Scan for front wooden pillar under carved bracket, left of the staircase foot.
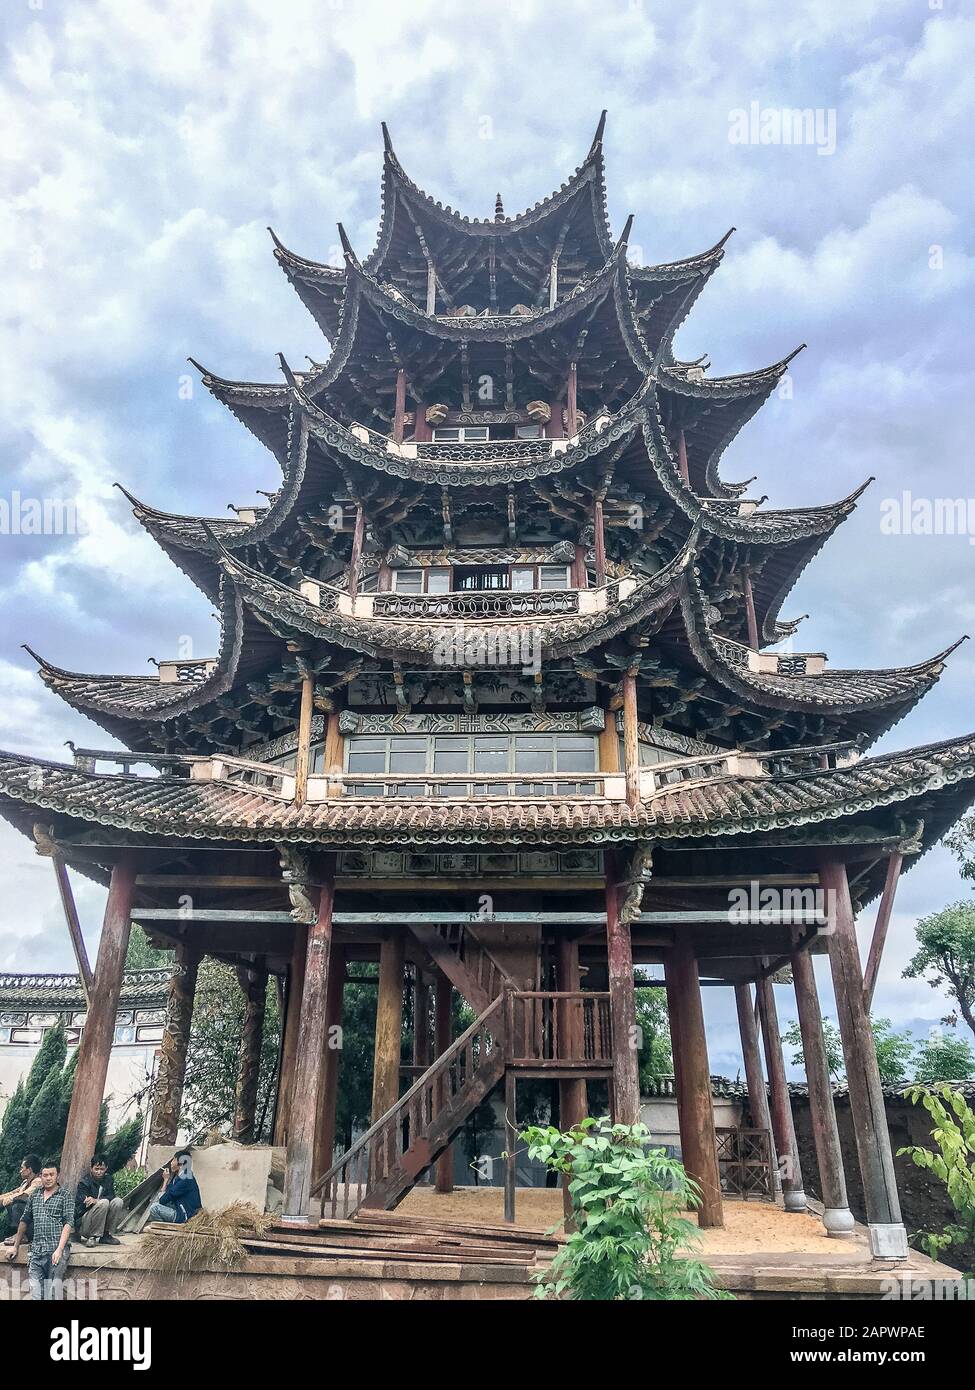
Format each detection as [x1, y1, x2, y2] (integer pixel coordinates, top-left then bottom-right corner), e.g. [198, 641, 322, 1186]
[281, 865, 335, 1226]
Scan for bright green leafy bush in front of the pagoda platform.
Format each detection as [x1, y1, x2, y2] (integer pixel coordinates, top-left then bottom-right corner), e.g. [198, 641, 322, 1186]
[520, 1116, 730, 1301]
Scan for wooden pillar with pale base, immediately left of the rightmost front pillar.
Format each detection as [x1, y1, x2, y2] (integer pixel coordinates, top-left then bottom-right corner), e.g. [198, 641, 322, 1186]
[791, 951, 854, 1237]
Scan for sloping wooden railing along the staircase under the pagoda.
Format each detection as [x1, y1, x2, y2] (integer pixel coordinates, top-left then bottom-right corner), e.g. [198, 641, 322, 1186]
[312, 997, 505, 1218]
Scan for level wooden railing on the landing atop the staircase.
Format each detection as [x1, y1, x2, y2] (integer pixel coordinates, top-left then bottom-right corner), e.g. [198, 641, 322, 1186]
[505, 990, 612, 1070]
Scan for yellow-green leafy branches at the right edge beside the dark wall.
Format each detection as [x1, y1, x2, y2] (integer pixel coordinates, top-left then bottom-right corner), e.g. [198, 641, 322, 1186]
[897, 1081, 975, 1259]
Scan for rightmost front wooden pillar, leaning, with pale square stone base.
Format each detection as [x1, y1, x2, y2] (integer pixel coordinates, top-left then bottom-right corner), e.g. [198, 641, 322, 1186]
[819, 855, 907, 1259]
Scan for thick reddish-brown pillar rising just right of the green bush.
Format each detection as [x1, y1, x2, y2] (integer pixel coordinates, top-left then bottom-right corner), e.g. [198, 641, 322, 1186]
[666, 933, 725, 1230]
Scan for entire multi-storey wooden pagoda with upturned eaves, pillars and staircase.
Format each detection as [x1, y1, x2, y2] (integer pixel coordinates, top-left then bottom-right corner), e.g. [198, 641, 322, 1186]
[0, 114, 975, 1258]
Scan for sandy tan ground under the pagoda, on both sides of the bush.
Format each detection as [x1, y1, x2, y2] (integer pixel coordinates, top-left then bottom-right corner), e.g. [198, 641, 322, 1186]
[398, 1187, 865, 1255]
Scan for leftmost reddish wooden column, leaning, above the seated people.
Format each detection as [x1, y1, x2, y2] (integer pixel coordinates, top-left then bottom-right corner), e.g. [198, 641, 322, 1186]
[61, 853, 136, 1190]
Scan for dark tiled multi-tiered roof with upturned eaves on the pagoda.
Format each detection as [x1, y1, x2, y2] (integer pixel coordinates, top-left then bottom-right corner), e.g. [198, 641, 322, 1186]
[0, 113, 975, 906]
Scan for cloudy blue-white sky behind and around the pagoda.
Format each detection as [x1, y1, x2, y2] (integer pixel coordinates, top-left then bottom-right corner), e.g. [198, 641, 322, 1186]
[0, 0, 975, 1074]
